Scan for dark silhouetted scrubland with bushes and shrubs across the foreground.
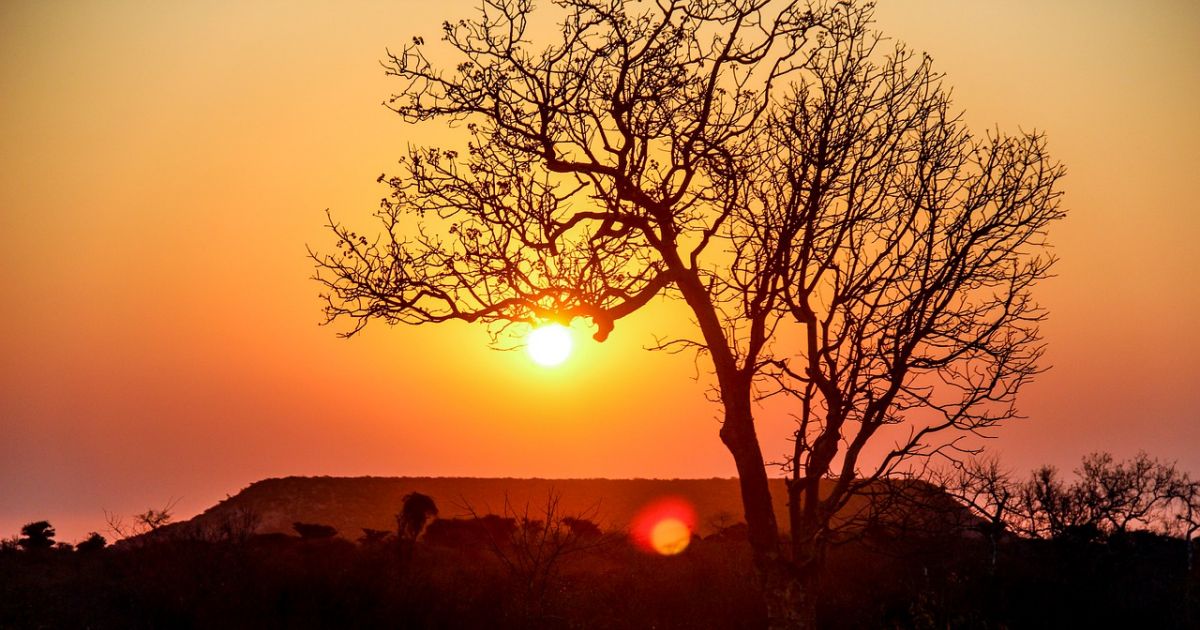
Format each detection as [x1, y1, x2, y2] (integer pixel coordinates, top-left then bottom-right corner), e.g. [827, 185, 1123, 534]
[0, 454, 1200, 629]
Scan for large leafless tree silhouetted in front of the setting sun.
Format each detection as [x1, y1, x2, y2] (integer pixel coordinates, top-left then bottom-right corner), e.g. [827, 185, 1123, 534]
[312, 0, 1063, 626]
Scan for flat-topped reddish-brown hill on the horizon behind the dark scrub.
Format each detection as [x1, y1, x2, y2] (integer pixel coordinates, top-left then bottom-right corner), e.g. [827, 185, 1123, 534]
[154, 476, 965, 540]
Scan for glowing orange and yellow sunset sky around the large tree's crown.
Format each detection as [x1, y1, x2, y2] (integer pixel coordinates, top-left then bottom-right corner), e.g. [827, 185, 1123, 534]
[0, 0, 1200, 541]
